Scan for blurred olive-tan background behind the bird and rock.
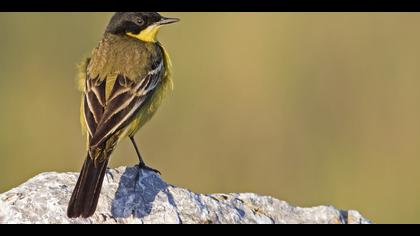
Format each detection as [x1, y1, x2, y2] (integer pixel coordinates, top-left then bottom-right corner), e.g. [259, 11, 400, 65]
[0, 13, 420, 223]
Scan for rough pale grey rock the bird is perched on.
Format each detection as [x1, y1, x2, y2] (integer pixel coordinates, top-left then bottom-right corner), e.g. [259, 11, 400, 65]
[0, 167, 370, 224]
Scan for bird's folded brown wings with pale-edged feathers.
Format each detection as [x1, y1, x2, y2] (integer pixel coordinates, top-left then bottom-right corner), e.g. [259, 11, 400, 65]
[84, 63, 163, 148]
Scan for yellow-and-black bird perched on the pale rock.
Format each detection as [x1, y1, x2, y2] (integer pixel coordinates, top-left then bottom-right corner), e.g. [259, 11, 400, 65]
[67, 12, 179, 218]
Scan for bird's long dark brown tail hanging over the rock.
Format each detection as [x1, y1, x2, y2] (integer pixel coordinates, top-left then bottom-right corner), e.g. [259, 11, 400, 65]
[67, 152, 108, 218]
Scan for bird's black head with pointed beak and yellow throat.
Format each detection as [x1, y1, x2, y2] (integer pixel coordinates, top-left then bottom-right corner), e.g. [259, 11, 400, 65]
[106, 12, 179, 39]
